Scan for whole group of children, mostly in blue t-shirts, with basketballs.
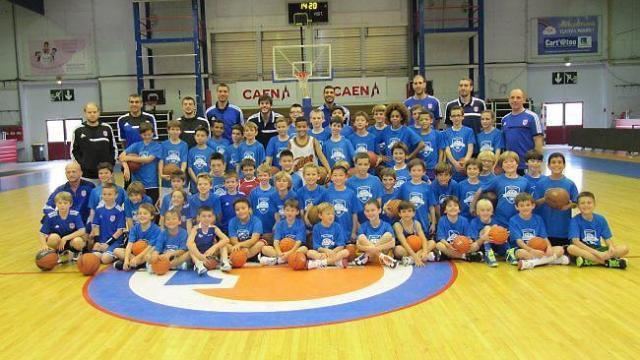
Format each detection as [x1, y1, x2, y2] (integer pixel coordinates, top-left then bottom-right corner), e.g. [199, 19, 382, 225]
[41, 100, 628, 275]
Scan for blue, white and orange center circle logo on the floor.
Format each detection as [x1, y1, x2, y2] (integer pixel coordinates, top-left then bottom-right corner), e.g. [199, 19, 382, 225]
[84, 262, 457, 330]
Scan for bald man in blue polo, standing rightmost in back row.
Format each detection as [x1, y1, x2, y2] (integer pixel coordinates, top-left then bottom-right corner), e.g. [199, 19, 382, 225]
[502, 89, 544, 175]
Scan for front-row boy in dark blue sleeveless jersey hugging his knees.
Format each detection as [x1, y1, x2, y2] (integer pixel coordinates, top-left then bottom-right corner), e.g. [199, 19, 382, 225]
[187, 206, 231, 276]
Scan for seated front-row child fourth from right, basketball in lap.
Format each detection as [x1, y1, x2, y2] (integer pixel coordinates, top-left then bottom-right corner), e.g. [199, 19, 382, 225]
[436, 196, 483, 262]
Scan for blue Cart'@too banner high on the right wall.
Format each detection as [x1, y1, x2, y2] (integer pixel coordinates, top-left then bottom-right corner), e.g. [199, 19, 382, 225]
[538, 16, 599, 55]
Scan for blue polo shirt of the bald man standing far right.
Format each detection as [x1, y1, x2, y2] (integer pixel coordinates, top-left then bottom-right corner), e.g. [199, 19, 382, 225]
[502, 110, 543, 169]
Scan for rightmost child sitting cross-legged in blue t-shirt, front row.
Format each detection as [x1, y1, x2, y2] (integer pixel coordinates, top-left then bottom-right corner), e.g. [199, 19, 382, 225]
[567, 191, 629, 269]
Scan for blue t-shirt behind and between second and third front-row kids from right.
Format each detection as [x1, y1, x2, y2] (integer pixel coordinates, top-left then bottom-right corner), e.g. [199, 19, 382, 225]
[482, 174, 529, 227]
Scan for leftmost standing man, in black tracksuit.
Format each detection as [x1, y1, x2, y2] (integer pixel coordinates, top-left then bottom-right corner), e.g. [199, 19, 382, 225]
[71, 102, 118, 184]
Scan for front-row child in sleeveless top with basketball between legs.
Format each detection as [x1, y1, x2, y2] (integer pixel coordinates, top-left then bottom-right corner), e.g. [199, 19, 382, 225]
[393, 201, 439, 267]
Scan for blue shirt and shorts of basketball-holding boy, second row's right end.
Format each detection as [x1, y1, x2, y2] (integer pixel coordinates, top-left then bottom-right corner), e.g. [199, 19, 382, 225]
[533, 176, 578, 238]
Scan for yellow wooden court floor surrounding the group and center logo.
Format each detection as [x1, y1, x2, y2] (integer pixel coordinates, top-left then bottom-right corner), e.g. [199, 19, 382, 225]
[0, 151, 640, 359]
